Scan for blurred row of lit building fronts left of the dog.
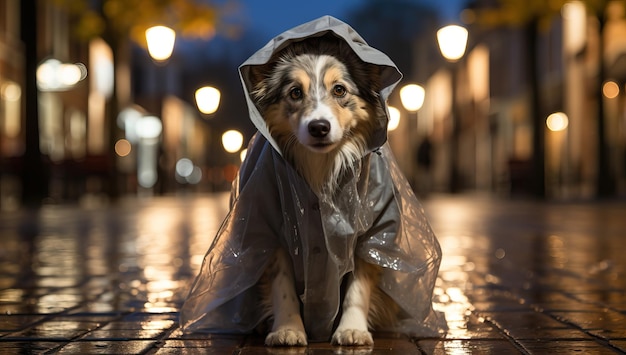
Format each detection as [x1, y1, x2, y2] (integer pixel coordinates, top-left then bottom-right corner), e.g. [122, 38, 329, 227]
[0, 0, 239, 209]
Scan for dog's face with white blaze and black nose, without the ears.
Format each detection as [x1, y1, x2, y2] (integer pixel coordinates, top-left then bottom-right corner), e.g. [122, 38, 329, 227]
[265, 54, 369, 153]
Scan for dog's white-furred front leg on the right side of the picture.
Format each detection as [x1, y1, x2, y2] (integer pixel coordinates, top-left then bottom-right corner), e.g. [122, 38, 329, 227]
[332, 259, 377, 345]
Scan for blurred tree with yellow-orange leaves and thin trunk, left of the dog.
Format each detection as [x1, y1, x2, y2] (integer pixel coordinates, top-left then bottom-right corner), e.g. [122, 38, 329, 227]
[45, 0, 240, 198]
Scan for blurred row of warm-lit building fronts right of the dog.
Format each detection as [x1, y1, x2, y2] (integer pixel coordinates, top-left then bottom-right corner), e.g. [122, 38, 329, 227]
[404, 0, 626, 198]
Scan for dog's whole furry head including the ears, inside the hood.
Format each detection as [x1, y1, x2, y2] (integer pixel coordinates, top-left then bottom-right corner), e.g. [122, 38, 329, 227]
[252, 39, 382, 155]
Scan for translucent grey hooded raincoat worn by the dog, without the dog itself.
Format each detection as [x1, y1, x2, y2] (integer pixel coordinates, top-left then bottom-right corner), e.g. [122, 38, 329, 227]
[180, 16, 446, 341]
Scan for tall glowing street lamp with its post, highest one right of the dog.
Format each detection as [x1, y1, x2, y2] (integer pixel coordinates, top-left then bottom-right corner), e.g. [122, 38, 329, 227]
[437, 25, 468, 193]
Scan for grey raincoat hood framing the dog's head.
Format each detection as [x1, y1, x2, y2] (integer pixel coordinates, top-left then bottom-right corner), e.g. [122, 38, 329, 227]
[239, 16, 402, 156]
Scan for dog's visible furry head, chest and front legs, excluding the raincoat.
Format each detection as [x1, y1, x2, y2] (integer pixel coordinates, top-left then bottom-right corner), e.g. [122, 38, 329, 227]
[251, 35, 398, 346]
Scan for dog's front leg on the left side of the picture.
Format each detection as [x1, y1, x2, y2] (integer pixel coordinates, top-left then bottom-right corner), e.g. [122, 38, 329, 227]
[265, 249, 307, 346]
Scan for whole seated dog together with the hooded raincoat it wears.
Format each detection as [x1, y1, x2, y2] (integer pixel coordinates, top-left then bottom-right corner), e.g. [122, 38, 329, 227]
[180, 16, 447, 346]
